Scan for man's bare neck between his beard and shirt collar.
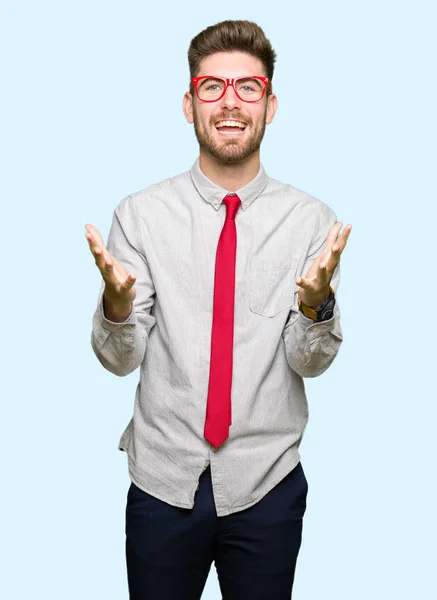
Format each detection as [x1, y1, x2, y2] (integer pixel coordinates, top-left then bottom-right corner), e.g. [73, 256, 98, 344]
[199, 148, 260, 192]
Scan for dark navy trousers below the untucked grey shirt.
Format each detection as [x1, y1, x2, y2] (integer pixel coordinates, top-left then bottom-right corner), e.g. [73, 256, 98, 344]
[126, 463, 308, 600]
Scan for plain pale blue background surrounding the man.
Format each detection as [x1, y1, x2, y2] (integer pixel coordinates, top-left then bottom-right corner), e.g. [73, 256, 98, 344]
[0, 0, 437, 600]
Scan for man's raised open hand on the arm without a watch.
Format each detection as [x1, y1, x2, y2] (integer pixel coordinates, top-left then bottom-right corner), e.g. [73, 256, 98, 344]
[85, 224, 136, 322]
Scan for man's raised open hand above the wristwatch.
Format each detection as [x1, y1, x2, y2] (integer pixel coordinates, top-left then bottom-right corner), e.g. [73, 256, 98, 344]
[296, 222, 352, 308]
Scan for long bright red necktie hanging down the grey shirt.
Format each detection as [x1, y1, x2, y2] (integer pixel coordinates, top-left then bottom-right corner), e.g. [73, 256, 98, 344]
[204, 195, 241, 448]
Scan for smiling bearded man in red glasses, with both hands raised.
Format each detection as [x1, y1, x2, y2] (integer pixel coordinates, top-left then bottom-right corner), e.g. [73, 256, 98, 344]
[86, 21, 351, 600]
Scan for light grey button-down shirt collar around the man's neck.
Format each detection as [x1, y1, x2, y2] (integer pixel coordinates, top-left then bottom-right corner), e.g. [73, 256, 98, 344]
[190, 158, 268, 210]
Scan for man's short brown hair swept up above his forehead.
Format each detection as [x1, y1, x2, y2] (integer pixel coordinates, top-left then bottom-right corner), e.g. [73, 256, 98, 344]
[188, 20, 276, 93]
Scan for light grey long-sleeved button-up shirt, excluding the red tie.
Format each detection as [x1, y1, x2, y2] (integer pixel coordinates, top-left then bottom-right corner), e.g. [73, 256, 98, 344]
[91, 159, 342, 516]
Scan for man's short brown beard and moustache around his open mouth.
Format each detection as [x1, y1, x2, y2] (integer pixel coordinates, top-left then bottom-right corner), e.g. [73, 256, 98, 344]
[193, 105, 267, 165]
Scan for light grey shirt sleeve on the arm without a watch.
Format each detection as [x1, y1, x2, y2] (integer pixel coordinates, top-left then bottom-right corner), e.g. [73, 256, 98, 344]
[91, 197, 156, 377]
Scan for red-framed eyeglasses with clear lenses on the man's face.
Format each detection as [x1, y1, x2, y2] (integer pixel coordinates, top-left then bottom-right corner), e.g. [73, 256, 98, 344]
[191, 75, 269, 102]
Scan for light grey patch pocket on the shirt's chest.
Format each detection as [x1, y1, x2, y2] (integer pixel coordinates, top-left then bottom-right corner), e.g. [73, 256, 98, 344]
[249, 258, 297, 317]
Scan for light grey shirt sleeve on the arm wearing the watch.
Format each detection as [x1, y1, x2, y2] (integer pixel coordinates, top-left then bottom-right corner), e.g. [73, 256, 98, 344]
[282, 203, 343, 377]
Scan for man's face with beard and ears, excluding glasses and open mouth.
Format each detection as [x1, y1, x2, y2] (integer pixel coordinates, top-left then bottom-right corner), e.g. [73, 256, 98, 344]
[183, 52, 277, 164]
